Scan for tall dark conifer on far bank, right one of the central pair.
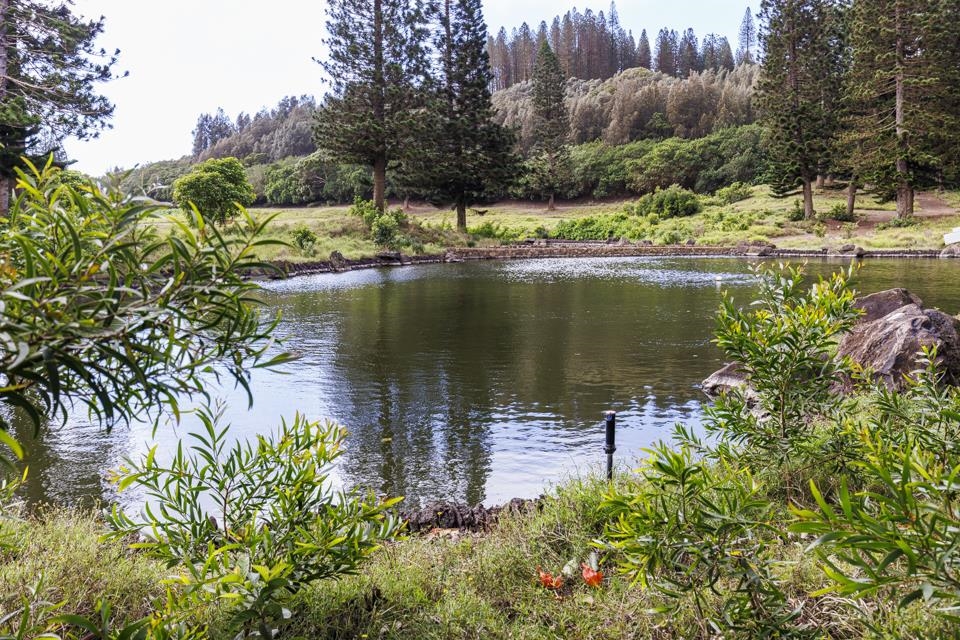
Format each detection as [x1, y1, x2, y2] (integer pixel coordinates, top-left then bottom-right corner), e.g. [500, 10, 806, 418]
[404, 0, 516, 231]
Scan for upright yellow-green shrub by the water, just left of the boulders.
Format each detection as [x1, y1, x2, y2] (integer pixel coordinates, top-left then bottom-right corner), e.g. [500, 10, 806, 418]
[707, 268, 857, 480]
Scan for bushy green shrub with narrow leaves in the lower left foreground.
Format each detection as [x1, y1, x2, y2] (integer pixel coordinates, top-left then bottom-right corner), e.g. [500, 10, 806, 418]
[107, 411, 398, 638]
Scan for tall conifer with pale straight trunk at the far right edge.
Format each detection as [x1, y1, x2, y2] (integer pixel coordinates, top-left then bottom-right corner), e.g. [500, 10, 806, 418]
[845, 0, 960, 218]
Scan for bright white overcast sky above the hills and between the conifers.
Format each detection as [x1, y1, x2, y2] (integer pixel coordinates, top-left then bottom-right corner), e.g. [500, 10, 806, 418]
[67, 0, 759, 175]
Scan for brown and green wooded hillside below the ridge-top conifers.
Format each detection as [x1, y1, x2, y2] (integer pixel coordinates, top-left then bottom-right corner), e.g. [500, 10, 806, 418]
[123, 65, 763, 205]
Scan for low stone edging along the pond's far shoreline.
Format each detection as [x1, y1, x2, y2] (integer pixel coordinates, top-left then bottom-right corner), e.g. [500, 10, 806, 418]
[253, 240, 956, 278]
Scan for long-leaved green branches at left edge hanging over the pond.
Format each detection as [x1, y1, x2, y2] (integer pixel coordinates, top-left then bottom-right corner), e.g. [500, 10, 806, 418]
[0, 160, 286, 470]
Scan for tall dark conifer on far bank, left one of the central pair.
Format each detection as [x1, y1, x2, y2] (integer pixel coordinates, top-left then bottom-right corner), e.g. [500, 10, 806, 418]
[314, 0, 428, 210]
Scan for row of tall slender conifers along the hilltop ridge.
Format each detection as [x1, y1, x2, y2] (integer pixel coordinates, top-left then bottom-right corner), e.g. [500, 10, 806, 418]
[487, 3, 757, 91]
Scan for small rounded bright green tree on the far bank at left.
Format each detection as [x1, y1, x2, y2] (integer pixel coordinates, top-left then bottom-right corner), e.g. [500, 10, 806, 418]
[173, 158, 257, 224]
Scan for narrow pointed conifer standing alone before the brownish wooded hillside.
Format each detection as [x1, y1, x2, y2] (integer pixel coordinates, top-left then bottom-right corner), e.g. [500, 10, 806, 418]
[532, 42, 569, 210]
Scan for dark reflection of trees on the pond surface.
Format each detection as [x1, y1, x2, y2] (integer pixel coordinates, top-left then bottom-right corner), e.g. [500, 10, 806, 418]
[314, 264, 728, 502]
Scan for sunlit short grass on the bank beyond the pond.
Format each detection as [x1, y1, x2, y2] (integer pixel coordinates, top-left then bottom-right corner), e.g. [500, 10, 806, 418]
[150, 186, 960, 262]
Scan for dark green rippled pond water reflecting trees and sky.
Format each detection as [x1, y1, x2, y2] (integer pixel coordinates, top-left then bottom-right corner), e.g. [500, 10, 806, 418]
[16, 258, 960, 504]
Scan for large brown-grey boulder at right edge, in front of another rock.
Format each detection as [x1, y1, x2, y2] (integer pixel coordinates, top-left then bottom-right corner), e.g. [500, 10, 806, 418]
[837, 303, 960, 389]
